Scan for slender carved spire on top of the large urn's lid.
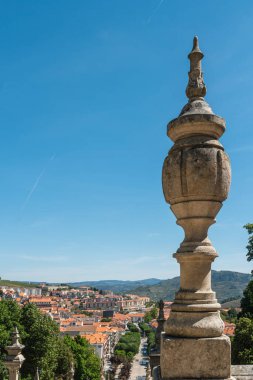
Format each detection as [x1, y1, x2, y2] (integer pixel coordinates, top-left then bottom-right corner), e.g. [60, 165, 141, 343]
[186, 36, 206, 101]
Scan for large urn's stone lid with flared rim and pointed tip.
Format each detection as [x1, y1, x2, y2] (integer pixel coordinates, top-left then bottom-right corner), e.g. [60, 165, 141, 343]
[167, 36, 225, 141]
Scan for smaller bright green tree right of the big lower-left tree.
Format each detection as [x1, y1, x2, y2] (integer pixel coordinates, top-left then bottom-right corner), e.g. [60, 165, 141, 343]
[64, 336, 101, 380]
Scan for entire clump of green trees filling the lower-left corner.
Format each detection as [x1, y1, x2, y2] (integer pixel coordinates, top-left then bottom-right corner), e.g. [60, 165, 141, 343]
[0, 300, 100, 380]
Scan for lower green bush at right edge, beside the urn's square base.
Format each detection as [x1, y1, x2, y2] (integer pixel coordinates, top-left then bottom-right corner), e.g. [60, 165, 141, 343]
[232, 318, 253, 364]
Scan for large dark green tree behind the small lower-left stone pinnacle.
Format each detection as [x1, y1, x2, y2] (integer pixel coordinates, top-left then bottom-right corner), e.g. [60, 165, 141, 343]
[0, 300, 73, 380]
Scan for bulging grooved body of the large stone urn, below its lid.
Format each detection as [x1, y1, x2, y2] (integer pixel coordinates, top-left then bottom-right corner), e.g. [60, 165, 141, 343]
[163, 139, 230, 205]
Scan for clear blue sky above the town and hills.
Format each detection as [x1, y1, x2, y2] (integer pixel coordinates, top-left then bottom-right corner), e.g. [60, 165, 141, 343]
[0, 0, 253, 281]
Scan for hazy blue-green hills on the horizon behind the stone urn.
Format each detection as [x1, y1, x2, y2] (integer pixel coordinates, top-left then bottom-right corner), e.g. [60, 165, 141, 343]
[69, 271, 251, 302]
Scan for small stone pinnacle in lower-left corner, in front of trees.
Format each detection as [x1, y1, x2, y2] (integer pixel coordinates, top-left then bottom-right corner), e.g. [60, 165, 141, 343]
[4, 328, 25, 380]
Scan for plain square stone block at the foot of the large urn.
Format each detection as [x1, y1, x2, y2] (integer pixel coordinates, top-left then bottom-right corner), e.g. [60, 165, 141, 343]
[160, 335, 231, 380]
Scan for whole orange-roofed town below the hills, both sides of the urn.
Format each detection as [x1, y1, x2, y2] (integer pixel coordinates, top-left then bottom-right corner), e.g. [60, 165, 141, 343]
[0, 281, 239, 373]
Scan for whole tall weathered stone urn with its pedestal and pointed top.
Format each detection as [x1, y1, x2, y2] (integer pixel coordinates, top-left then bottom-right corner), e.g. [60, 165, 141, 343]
[161, 37, 231, 379]
